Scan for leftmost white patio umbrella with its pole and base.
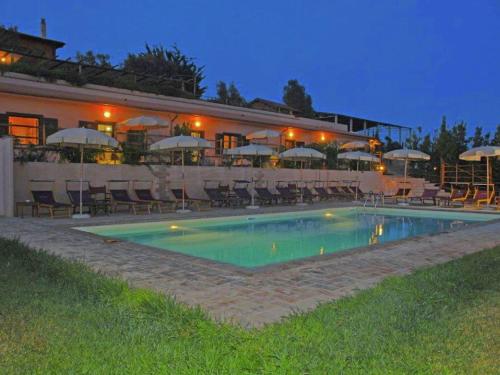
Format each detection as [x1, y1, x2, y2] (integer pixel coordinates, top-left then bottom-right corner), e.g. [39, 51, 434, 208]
[46, 128, 119, 219]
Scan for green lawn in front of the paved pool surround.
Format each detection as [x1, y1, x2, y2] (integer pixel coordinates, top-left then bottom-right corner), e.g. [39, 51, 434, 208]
[0, 239, 500, 374]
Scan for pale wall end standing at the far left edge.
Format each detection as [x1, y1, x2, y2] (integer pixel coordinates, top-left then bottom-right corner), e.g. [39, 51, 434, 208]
[0, 137, 14, 216]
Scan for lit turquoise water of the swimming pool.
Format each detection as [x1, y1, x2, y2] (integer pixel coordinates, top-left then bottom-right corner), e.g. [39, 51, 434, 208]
[76, 208, 495, 268]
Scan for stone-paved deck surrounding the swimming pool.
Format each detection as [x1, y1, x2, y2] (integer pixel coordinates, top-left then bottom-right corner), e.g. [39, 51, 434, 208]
[0, 203, 500, 327]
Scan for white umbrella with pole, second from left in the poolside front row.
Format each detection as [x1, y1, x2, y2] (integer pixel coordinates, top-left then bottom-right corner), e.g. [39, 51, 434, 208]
[149, 135, 212, 213]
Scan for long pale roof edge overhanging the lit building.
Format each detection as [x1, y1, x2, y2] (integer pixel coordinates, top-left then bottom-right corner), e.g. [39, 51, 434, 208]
[0, 72, 370, 139]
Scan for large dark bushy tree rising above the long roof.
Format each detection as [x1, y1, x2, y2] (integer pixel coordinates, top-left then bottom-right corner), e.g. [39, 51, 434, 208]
[123, 44, 206, 97]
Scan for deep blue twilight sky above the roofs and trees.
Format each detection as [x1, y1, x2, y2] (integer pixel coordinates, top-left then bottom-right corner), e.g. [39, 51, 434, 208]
[0, 0, 500, 135]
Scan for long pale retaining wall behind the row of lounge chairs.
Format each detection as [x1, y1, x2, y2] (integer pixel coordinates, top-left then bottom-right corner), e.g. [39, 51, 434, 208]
[14, 162, 424, 201]
